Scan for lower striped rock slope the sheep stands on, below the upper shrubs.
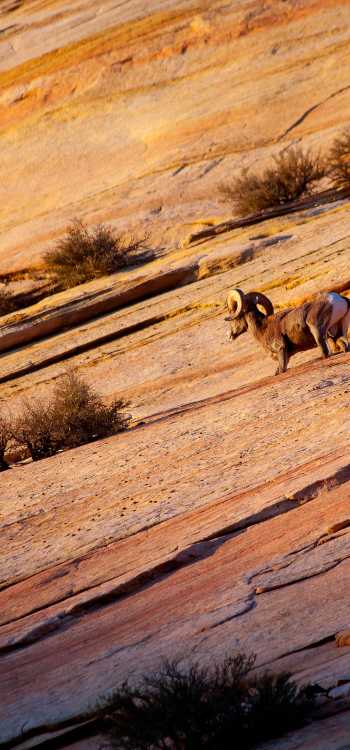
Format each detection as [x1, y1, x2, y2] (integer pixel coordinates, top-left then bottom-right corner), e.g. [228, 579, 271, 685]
[0, 201, 350, 747]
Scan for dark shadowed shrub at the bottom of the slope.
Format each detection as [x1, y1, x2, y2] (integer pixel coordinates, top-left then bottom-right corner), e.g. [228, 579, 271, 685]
[100, 654, 310, 750]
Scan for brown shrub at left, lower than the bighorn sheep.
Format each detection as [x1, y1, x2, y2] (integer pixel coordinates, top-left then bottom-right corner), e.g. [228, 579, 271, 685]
[12, 370, 130, 461]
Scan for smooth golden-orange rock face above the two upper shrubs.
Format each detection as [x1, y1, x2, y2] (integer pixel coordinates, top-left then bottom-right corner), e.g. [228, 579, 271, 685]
[0, 0, 350, 274]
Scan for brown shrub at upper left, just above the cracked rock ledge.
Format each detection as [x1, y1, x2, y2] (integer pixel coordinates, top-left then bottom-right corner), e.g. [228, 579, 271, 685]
[44, 220, 147, 289]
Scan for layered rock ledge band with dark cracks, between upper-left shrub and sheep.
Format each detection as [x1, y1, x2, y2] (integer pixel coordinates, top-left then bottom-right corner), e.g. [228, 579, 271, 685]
[0, 197, 350, 362]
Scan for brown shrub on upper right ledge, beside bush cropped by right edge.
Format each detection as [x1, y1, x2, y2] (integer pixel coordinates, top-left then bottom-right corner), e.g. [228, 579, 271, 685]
[220, 146, 326, 215]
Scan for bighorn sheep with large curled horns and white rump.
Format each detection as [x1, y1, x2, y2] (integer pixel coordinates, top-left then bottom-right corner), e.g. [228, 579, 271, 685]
[225, 289, 350, 375]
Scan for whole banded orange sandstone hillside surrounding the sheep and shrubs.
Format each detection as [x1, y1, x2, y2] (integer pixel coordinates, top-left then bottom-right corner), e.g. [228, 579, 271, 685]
[0, 0, 350, 750]
